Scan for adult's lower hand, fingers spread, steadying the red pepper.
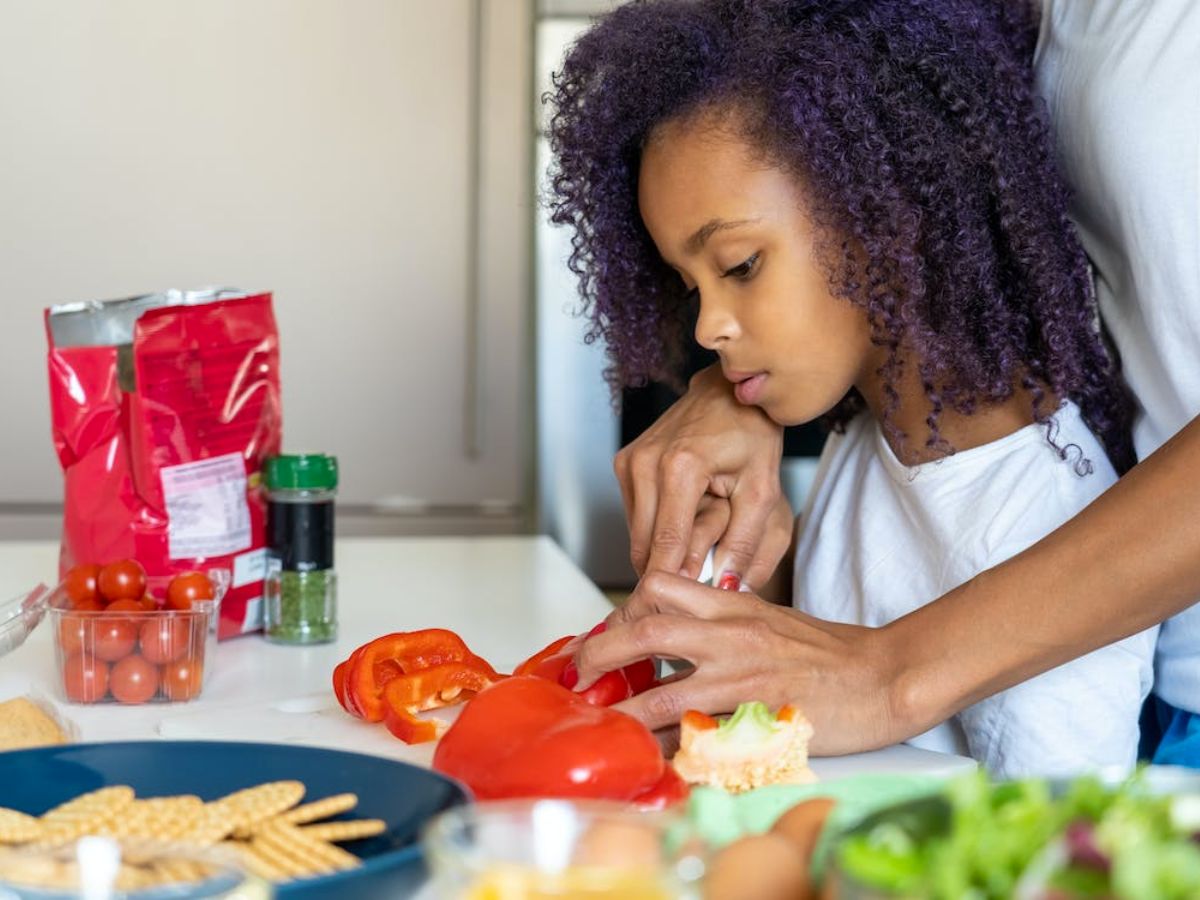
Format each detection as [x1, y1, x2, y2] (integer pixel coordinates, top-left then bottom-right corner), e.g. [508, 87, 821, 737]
[575, 572, 907, 755]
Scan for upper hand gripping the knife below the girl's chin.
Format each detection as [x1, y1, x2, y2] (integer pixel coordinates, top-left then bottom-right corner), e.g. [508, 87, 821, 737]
[613, 365, 792, 587]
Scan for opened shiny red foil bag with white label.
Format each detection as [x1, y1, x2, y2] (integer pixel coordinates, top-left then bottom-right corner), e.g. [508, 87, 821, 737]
[46, 290, 282, 637]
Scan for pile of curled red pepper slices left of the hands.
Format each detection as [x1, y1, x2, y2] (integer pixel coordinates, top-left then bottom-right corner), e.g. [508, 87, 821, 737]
[334, 628, 504, 744]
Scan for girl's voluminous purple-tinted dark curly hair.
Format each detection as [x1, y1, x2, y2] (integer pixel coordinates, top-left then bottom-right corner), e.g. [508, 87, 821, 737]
[548, 0, 1133, 469]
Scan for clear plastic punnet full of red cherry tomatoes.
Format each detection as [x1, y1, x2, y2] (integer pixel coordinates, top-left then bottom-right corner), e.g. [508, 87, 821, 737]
[32, 559, 229, 704]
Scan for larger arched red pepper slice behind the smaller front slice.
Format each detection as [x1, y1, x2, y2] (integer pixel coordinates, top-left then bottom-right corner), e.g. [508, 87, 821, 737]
[345, 628, 499, 722]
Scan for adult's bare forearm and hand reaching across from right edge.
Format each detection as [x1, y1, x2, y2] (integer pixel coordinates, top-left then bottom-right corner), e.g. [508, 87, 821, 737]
[576, 419, 1200, 754]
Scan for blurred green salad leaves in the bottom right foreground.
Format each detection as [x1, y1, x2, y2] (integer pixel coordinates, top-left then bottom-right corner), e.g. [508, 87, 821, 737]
[828, 767, 1200, 900]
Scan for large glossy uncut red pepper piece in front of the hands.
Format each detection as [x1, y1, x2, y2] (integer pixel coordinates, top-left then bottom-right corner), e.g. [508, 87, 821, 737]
[433, 676, 666, 800]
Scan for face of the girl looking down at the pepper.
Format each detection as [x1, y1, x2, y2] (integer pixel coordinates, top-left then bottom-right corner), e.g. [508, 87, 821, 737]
[638, 115, 882, 425]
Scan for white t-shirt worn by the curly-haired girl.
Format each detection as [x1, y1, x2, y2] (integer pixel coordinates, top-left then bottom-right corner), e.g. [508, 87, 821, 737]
[793, 403, 1157, 776]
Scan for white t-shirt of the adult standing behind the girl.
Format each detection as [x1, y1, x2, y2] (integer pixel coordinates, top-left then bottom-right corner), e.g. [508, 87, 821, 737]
[1037, 0, 1200, 713]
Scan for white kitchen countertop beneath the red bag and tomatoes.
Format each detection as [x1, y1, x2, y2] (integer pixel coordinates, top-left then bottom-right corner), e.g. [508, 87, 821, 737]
[0, 536, 973, 778]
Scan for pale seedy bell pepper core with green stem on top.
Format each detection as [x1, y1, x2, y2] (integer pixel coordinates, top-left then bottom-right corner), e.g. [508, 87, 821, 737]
[674, 702, 816, 793]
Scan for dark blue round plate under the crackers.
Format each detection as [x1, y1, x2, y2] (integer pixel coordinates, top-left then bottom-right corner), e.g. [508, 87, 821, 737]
[0, 740, 467, 900]
